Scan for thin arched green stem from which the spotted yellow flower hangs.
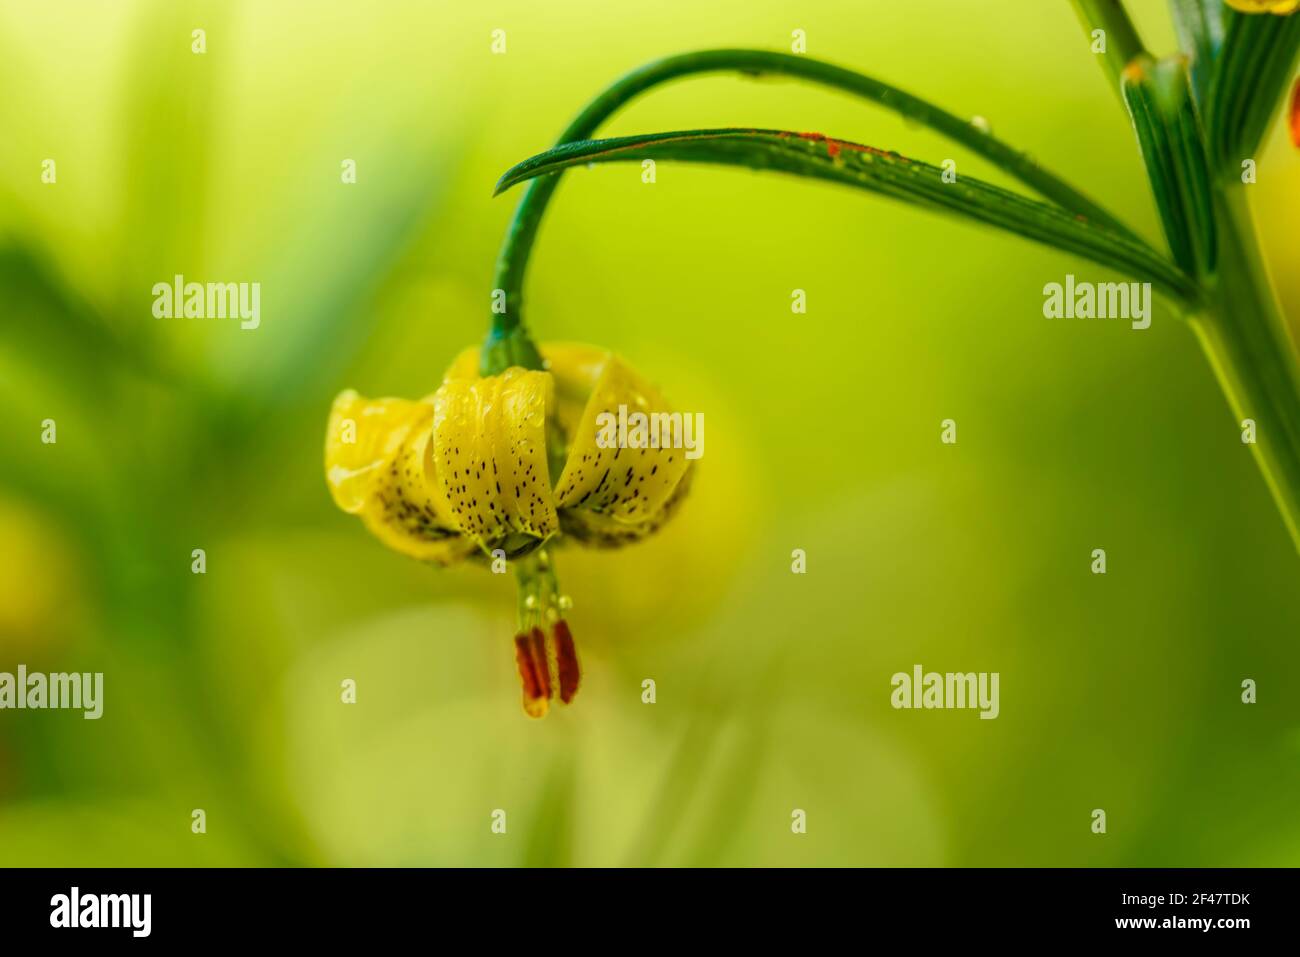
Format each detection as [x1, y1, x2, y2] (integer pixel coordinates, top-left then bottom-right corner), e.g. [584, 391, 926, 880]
[481, 49, 1136, 374]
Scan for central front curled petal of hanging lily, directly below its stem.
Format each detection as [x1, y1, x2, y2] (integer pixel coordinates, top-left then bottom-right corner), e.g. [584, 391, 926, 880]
[433, 368, 559, 554]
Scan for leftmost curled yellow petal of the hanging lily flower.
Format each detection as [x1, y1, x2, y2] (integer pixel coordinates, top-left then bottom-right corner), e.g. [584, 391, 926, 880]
[325, 390, 473, 564]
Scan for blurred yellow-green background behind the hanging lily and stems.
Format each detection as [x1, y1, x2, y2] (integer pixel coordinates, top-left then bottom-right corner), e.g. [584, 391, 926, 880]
[0, 0, 1300, 866]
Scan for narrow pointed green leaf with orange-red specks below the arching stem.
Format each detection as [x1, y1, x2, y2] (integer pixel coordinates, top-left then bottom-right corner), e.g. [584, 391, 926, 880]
[497, 129, 1197, 300]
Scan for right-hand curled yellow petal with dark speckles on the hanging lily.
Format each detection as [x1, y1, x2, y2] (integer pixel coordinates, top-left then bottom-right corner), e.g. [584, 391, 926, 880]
[555, 355, 690, 530]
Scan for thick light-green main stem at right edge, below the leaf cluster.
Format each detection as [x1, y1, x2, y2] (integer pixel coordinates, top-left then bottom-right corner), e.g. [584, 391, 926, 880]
[1192, 185, 1300, 551]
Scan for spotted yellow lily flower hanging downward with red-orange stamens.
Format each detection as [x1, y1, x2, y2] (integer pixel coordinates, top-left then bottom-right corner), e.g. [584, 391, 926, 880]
[325, 345, 692, 718]
